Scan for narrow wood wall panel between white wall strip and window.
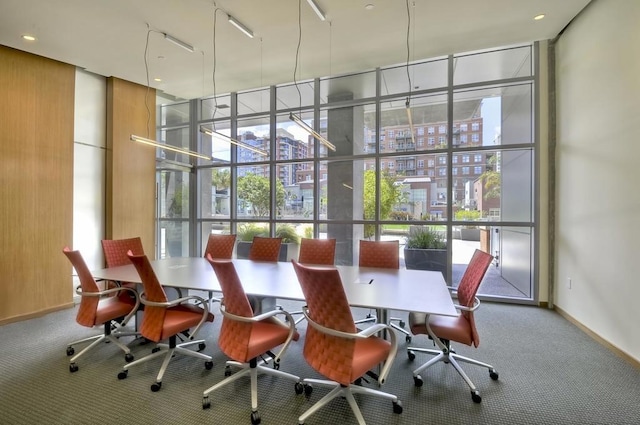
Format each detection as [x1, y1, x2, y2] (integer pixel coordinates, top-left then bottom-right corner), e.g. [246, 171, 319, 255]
[105, 77, 156, 258]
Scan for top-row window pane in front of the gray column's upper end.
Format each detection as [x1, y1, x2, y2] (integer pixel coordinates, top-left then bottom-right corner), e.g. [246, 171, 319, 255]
[320, 71, 376, 105]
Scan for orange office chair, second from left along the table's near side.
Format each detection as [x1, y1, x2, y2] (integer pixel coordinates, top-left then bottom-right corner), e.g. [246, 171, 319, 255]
[118, 252, 213, 392]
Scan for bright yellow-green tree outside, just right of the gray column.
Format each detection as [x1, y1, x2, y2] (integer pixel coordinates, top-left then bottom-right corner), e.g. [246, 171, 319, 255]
[363, 170, 402, 238]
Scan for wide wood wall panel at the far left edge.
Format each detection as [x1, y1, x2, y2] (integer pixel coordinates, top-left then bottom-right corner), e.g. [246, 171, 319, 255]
[0, 46, 75, 324]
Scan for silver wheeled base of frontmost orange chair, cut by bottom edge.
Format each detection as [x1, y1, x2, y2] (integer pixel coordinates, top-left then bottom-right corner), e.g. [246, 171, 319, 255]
[298, 378, 402, 425]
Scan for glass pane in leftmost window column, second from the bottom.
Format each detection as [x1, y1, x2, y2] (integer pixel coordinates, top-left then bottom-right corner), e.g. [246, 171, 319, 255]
[159, 170, 189, 218]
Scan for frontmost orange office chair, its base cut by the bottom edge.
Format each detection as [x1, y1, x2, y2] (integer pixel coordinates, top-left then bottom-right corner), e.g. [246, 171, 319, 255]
[293, 261, 402, 425]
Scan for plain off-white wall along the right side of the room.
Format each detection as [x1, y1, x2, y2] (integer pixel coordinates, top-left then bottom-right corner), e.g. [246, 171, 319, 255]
[555, 0, 640, 361]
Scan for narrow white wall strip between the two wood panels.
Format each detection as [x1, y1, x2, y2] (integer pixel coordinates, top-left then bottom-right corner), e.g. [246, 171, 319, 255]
[73, 69, 107, 288]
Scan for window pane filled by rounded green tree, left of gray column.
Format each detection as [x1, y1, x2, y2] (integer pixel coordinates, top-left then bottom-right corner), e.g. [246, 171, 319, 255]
[237, 165, 272, 218]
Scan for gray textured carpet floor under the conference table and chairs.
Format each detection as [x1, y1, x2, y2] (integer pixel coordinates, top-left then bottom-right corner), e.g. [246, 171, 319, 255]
[0, 303, 640, 425]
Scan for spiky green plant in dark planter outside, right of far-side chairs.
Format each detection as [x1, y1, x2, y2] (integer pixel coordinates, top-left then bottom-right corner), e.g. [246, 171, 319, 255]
[404, 226, 448, 280]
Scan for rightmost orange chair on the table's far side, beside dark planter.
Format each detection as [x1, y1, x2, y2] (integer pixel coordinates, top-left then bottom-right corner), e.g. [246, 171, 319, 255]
[356, 240, 411, 342]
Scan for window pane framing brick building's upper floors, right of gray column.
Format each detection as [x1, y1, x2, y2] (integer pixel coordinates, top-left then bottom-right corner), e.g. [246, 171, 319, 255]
[378, 94, 448, 153]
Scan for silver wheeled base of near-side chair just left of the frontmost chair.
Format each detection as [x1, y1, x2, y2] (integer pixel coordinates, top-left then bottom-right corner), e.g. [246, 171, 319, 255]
[202, 359, 304, 424]
